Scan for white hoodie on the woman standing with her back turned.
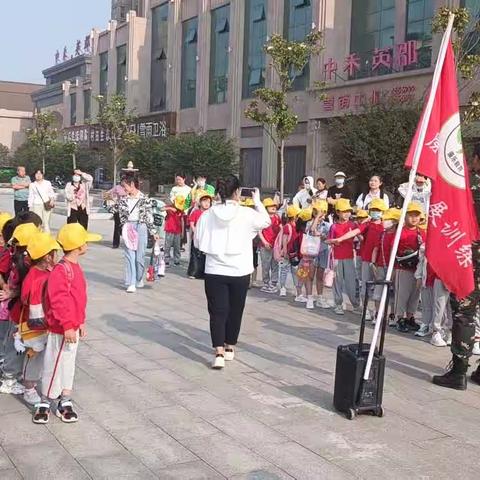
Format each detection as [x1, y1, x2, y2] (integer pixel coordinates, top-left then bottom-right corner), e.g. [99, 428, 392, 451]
[195, 201, 271, 277]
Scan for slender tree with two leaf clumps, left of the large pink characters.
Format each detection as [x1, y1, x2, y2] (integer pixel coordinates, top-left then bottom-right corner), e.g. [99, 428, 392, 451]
[245, 32, 323, 199]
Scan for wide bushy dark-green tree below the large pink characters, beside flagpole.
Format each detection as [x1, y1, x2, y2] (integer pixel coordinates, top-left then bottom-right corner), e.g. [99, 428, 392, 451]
[327, 101, 420, 189]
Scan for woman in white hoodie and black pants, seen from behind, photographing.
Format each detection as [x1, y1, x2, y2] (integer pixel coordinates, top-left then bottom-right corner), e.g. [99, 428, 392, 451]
[195, 175, 270, 369]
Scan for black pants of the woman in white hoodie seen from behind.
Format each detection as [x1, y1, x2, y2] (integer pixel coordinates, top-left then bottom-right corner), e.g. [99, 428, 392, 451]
[205, 274, 250, 348]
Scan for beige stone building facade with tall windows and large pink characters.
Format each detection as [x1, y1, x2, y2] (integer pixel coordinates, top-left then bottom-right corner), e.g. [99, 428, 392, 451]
[43, 0, 480, 192]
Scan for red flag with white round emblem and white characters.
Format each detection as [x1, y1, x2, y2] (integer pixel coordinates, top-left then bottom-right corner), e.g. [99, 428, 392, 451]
[406, 41, 478, 298]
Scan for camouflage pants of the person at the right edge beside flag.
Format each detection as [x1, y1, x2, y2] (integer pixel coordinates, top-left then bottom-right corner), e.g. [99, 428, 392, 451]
[451, 242, 480, 372]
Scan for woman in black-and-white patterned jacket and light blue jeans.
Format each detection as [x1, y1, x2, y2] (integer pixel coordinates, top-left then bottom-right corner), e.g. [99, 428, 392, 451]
[109, 173, 158, 293]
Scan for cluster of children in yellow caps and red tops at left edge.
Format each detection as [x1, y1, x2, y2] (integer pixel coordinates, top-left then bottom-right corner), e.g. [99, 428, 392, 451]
[0, 212, 101, 424]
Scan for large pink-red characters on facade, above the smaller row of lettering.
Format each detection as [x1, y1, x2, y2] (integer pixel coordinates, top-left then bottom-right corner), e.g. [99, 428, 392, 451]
[323, 40, 419, 81]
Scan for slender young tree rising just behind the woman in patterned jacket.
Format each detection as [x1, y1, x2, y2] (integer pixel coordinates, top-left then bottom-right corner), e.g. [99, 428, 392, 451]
[95, 95, 140, 182]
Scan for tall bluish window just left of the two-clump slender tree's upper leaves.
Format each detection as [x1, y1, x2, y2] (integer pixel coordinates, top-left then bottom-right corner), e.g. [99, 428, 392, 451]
[243, 0, 267, 98]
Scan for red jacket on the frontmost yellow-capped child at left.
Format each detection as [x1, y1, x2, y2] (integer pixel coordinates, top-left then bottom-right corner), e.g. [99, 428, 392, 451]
[45, 259, 87, 335]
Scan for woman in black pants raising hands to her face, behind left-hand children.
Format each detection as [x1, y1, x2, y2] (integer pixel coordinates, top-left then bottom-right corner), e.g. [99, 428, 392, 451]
[65, 169, 93, 230]
